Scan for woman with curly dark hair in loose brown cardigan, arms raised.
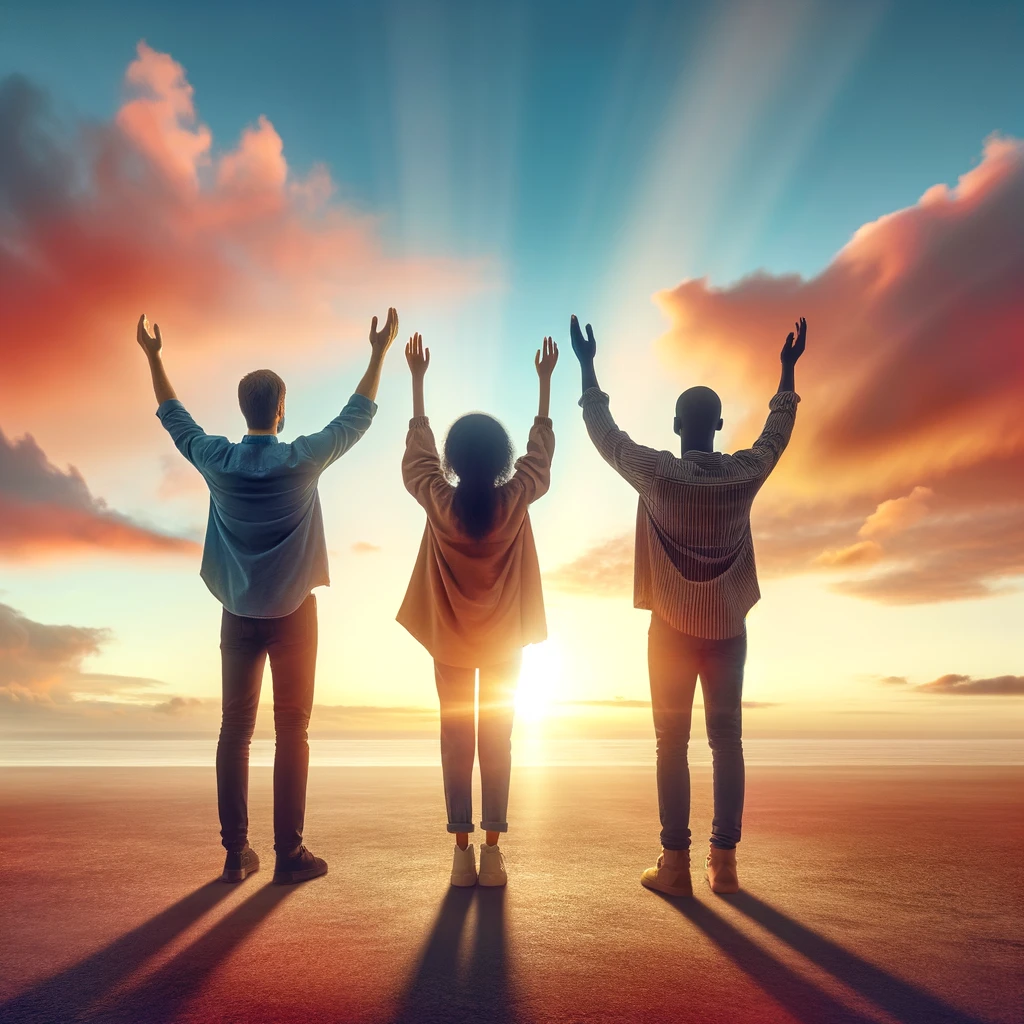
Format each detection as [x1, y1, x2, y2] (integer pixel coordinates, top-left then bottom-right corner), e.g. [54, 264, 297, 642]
[398, 334, 558, 886]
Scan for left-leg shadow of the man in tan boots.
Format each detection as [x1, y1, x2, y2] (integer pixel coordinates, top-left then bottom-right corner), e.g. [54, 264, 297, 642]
[656, 893, 873, 1024]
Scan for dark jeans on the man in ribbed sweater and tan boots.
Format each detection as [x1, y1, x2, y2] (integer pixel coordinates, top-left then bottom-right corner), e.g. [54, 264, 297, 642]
[647, 615, 746, 850]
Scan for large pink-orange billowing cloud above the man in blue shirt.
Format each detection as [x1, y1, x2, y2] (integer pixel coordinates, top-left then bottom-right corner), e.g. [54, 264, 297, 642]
[0, 43, 490, 444]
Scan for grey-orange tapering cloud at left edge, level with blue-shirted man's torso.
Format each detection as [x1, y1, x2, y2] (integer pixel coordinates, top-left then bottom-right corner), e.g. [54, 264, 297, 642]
[0, 430, 199, 559]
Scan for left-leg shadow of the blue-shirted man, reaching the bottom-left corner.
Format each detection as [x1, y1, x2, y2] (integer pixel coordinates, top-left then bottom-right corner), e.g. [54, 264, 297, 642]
[0, 880, 231, 1024]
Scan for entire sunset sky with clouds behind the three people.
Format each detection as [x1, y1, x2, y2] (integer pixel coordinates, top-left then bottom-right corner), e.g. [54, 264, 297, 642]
[0, 0, 1024, 736]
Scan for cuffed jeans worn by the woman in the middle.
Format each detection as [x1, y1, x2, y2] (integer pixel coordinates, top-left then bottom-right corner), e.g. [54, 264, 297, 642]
[434, 652, 522, 833]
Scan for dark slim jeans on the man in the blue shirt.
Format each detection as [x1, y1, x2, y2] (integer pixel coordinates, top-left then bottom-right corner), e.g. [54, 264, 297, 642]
[217, 594, 316, 857]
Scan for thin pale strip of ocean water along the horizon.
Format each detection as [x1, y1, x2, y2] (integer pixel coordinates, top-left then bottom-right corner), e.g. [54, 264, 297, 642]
[0, 736, 1024, 768]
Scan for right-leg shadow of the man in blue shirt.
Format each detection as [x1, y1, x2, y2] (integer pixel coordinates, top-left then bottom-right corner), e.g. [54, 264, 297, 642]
[83, 884, 295, 1024]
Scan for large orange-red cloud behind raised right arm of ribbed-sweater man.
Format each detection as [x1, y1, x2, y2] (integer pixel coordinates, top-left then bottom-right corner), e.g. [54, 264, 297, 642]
[657, 137, 1024, 603]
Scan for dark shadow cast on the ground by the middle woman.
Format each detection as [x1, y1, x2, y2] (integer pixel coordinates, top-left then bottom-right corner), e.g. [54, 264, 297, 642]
[392, 888, 522, 1024]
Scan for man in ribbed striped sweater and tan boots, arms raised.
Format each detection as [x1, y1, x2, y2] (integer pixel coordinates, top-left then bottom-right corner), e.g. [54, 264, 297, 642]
[569, 316, 807, 896]
